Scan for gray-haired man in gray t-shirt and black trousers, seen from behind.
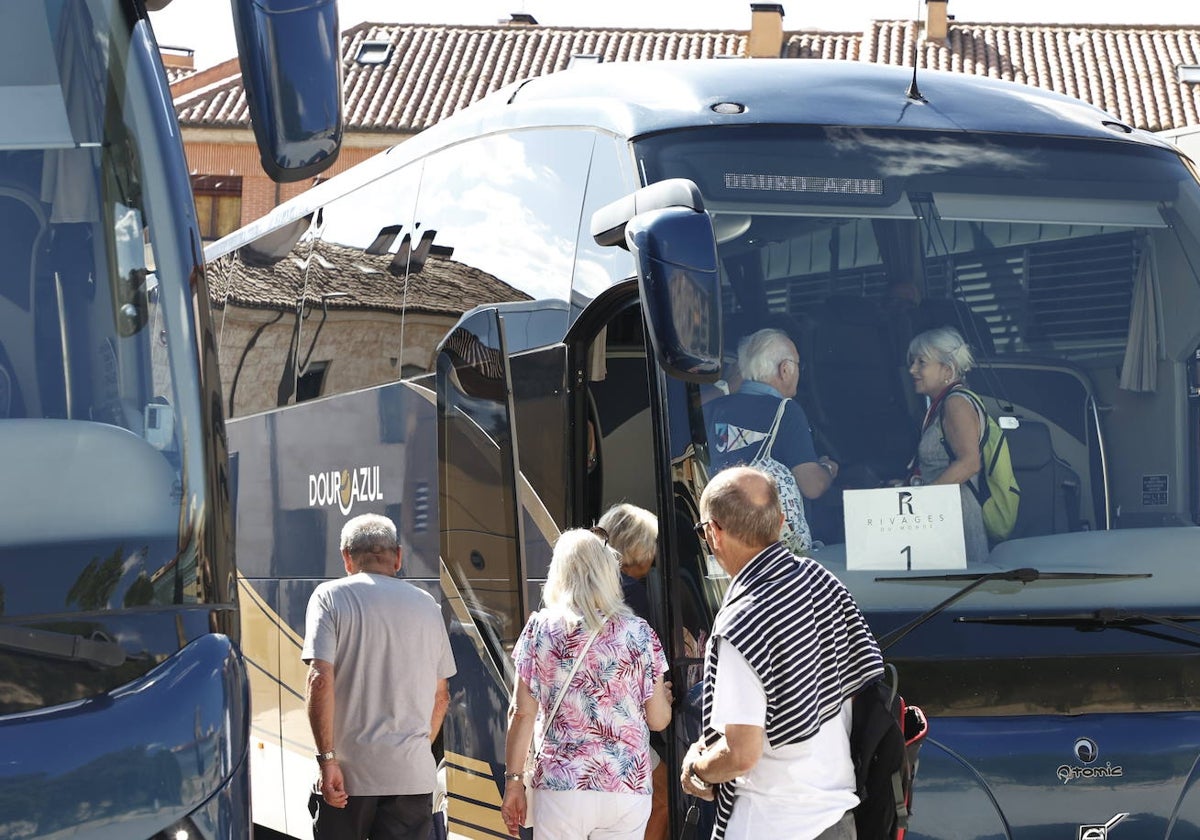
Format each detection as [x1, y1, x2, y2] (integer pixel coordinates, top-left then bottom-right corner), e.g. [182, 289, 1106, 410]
[300, 514, 455, 840]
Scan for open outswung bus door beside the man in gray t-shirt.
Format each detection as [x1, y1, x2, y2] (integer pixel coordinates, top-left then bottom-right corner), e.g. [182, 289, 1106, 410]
[437, 308, 528, 835]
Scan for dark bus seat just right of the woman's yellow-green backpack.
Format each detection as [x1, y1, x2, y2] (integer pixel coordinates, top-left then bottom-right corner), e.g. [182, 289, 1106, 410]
[1004, 420, 1080, 539]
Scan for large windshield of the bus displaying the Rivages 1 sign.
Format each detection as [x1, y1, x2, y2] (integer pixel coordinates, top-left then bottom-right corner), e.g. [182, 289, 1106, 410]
[637, 126, 1200, 681]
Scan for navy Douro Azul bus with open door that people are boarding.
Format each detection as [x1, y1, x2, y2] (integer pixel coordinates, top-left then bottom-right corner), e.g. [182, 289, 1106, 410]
[208, 60, 1200, 840]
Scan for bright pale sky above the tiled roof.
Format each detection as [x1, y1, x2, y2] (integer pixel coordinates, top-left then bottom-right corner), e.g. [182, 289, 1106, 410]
[150, 0, 1200, 70]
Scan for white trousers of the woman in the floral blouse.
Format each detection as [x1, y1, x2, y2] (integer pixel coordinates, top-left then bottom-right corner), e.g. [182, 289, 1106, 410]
[533, 788, 653, 840]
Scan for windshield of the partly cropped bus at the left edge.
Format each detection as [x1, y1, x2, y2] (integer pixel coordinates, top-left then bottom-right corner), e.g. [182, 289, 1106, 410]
[0, 0, 202, 709]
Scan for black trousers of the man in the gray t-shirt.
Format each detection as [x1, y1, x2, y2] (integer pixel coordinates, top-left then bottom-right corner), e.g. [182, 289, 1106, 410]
[308, 793, 433, 840]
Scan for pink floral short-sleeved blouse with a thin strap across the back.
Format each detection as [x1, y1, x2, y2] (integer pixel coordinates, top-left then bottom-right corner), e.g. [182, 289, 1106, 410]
[512, 611, 667, 796]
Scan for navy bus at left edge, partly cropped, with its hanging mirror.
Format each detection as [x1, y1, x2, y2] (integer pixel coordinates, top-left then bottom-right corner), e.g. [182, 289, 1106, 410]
[0, 0, 341, 840]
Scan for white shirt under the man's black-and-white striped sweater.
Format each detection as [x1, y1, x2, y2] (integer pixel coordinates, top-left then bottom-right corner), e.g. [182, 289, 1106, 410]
[712, 640, 858, 840]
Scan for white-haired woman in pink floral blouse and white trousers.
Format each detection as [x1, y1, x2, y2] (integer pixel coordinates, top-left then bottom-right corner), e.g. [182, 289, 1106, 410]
[502, 529, 671, 840]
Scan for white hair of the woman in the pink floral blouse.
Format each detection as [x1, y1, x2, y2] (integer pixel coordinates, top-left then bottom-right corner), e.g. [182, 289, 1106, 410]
[542, 528, 634, 630]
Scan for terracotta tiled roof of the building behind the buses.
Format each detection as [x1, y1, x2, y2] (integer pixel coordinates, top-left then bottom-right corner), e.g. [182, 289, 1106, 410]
[173, 20, 1200, 132]
